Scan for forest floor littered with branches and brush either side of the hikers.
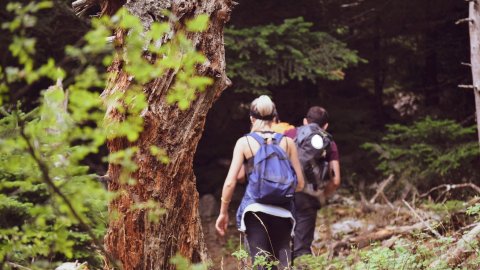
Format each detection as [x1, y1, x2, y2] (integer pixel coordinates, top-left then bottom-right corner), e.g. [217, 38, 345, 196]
[204, 191, 480, 270]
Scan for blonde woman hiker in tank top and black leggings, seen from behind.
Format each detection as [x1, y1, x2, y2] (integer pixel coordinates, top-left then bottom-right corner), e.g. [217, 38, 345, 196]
[215, 95, 304, 269]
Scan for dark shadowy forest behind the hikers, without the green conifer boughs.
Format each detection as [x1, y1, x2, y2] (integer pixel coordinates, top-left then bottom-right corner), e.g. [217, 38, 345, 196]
[194, 0, 475, 197]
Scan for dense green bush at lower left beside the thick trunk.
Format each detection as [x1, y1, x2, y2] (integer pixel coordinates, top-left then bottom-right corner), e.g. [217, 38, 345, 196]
[0, 96, 109, 267]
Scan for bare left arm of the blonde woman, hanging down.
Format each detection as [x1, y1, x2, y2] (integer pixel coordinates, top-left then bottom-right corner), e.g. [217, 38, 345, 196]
[215, 138, 244, 235]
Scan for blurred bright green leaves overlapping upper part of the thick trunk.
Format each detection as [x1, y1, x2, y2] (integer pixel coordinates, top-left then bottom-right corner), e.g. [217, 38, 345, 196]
[113, 9, 213, 108]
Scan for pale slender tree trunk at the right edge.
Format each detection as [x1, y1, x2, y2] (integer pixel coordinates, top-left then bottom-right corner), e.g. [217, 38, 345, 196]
[469, 0, 480, 150]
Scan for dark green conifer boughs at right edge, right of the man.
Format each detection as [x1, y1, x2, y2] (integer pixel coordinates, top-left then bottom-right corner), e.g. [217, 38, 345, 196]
[363, 117, 479, 190]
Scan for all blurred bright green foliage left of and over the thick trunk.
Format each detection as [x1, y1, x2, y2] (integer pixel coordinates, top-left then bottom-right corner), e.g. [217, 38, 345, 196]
[0, 1, 212, 269]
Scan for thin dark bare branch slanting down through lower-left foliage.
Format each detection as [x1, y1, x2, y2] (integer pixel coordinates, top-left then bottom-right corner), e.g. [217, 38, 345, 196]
[18, 116, 121, 269]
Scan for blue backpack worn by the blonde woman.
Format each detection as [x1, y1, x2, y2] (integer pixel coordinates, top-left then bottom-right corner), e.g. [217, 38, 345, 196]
[246, 132, 297, 205]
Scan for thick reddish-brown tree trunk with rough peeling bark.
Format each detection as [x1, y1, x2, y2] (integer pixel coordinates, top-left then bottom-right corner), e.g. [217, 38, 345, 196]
[103, 0, 232, 269]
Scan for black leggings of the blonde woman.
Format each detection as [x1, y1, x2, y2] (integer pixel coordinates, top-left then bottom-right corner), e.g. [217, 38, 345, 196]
[245, 212, 292, 269]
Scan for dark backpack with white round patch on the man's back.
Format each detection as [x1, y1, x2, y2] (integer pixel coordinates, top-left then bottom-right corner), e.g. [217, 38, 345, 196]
[295, 123, 333, 189]
